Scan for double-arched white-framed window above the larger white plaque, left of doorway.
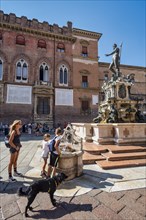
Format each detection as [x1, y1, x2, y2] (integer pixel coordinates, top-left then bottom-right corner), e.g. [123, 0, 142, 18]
[16, 59, 28, 81]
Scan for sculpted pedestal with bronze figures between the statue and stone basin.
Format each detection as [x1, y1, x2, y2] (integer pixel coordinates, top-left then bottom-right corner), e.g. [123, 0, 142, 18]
[93, 73, 144, 123]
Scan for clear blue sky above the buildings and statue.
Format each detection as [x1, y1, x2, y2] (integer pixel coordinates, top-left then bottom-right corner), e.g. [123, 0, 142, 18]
[0, 0, 146, 67]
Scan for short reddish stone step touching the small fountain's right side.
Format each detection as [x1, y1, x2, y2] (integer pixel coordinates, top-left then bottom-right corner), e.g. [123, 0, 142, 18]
[83, 151, 106, 164]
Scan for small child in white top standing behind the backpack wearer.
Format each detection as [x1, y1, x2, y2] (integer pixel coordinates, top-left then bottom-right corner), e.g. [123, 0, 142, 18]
[41, 134, 50, 177]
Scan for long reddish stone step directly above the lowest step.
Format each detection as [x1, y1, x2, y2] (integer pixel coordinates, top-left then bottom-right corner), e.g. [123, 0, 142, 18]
[102, 152, 146, 161]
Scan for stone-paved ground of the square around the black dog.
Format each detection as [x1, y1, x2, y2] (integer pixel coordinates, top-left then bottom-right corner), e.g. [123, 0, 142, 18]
[0, 135, 146, 220]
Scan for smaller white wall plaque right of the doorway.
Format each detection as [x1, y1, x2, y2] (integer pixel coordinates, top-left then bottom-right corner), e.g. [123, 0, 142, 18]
[55, 89, 73, 106]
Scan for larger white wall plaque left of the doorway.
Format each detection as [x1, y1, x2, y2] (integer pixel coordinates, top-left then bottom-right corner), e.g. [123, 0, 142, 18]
[7, 85, 32, 104]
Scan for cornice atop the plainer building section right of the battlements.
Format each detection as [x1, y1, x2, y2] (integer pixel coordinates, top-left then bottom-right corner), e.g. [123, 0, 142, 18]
[72, 28, 102, 40]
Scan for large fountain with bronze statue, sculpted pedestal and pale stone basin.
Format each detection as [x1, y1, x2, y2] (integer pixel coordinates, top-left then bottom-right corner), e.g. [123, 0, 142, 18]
[72, 44, 146, 145]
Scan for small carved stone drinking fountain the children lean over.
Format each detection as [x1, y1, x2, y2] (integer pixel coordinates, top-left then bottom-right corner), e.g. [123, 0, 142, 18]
[57, 124, 83, 180]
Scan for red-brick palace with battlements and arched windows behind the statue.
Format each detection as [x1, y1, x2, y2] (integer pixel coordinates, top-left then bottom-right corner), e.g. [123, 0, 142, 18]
[0, 11, 146, 127]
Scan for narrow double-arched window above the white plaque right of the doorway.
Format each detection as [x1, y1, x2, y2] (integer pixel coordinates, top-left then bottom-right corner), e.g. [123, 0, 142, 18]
[59, 65, 68, 86]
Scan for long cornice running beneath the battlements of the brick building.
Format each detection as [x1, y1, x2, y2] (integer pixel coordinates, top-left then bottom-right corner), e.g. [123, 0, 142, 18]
[0, 22, 76, 43]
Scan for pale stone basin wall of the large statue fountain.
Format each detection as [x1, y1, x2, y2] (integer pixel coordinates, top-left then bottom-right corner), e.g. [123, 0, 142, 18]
[72, 123, 146, 145]
